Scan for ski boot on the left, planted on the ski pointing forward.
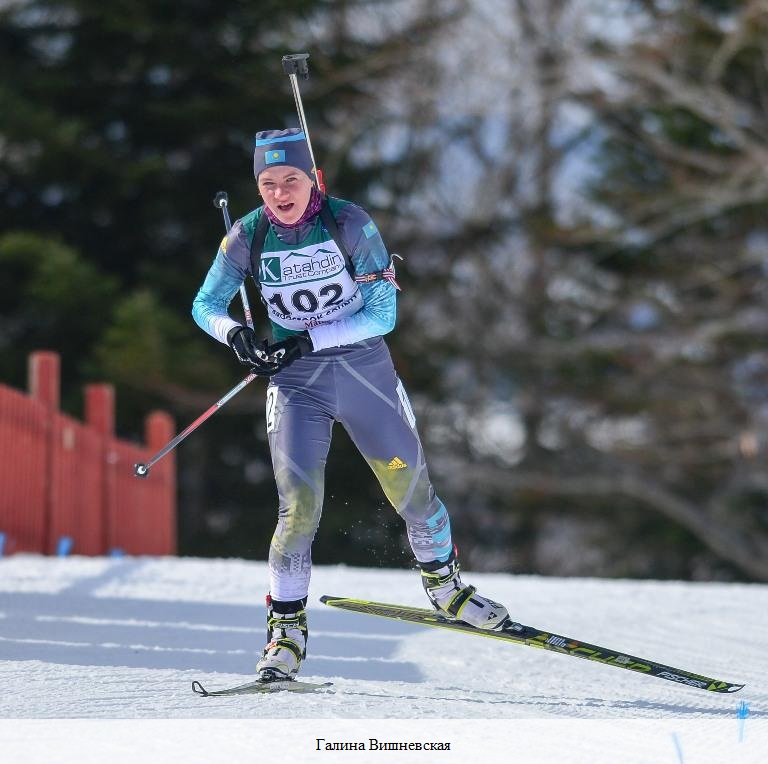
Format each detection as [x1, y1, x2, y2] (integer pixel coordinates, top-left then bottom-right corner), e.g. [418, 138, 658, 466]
[256, 595, 308, 682]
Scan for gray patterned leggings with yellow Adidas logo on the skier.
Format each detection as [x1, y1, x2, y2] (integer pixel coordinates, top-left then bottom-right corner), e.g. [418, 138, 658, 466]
[266, 337, 452, 600]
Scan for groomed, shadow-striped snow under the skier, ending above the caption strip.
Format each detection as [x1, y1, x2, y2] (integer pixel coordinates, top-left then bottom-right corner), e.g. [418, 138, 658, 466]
[0, 555, 768, 723]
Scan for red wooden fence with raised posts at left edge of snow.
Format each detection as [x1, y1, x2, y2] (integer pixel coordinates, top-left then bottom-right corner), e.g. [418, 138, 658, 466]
[0, 351, 176, 555]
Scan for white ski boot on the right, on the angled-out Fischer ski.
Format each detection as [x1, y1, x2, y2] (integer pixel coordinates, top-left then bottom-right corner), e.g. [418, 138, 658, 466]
[419, 549, 510, 631]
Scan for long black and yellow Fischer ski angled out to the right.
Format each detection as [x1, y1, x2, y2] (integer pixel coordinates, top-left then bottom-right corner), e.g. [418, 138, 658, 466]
[320, 595, 744, 693]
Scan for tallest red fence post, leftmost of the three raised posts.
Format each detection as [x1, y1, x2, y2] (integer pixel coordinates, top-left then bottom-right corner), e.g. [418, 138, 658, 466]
[27, 350, 61, 554]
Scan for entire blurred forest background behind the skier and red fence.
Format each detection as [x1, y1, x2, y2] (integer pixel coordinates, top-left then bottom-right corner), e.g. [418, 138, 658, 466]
[0, 0, 768, 581]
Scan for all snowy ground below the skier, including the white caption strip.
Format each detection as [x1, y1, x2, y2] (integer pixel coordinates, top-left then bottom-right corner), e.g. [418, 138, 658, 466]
[0, 555, 768, 764]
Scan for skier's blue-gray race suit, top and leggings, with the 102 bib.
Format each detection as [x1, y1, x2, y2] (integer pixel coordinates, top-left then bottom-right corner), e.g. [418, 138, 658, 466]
[192, 197, 453, 600]
